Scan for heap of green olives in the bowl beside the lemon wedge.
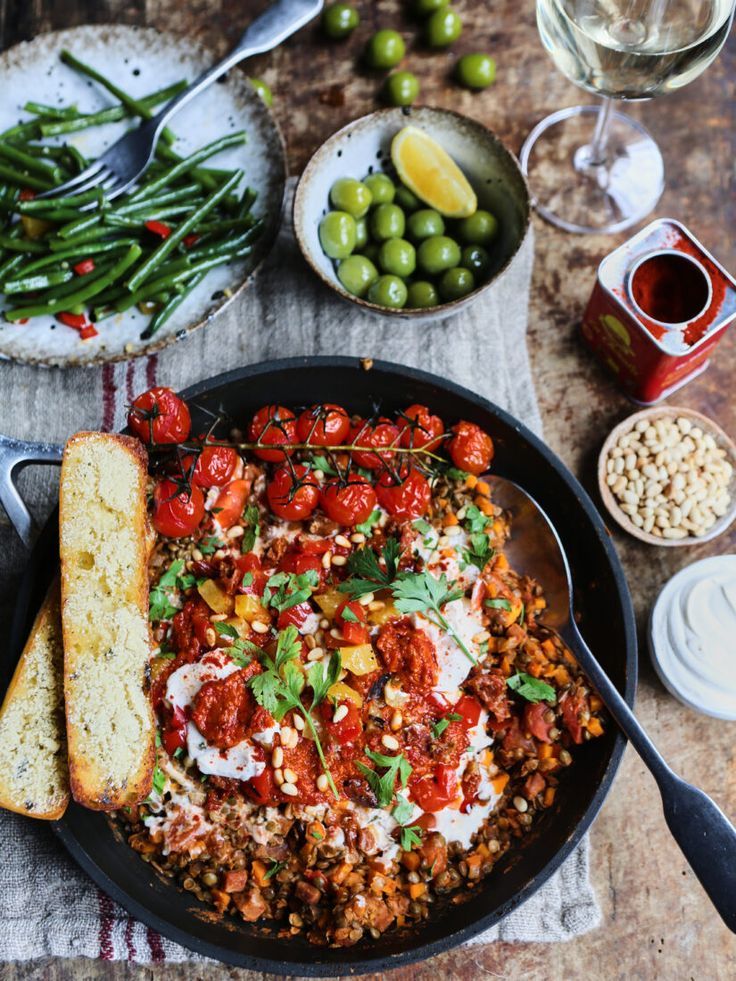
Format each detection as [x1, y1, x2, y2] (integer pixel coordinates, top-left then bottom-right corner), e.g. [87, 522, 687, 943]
[319, 172, 498, 310]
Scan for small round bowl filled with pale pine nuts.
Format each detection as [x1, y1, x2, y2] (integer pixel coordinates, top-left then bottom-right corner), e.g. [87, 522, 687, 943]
[598, 406, 736, 546]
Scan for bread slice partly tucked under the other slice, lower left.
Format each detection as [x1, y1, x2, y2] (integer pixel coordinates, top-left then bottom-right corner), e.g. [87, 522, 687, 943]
[0, 580, 69, 821]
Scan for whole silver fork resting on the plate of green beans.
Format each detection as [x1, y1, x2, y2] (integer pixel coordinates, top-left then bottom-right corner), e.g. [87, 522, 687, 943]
[37, 0, 324, 200]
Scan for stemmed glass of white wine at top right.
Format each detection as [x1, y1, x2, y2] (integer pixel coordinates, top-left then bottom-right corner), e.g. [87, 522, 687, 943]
[521, 0, 736, 232]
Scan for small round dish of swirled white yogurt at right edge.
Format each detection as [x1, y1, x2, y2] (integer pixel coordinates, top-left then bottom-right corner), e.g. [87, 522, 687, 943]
[650, 555, 736, 720]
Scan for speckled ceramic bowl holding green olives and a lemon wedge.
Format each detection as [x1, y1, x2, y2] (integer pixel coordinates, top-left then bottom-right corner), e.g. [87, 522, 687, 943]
[294, 108, 530, 321]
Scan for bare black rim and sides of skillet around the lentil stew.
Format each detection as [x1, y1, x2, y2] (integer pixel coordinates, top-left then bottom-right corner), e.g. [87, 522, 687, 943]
[5, 358, 637, 976]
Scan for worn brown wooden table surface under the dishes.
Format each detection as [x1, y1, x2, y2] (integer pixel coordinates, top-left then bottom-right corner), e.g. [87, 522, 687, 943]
[0, 0, 736, 981]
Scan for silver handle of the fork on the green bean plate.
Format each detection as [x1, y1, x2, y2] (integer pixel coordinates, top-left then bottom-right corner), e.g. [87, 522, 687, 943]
[145, 0, 324, 137]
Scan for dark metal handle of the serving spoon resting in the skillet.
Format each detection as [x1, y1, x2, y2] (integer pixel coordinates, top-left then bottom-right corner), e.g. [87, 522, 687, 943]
[561, 623, 736, 933]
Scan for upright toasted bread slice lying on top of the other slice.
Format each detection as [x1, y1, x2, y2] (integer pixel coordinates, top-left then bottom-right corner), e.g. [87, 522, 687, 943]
[59, 433, 156, 810]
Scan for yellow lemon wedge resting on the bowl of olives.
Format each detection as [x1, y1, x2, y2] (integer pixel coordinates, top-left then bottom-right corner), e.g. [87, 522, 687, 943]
[391, 126, 478, 218]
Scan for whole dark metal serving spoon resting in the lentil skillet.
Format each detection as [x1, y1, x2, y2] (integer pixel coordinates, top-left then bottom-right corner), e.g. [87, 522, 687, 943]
[485, 475, 736, 933]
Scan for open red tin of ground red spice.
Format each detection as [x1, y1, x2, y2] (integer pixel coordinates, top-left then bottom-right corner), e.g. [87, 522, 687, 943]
[582, 218, 736, 405]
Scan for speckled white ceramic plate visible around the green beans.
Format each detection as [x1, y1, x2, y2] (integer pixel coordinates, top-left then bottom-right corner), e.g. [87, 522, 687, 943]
[0, 25, 286, 367]
